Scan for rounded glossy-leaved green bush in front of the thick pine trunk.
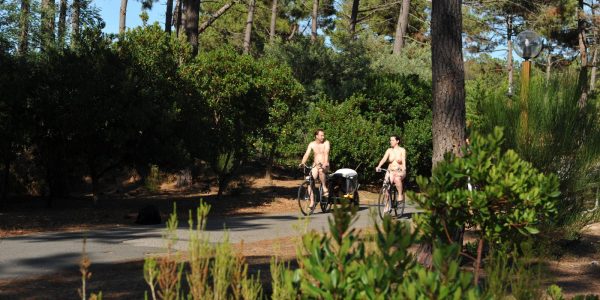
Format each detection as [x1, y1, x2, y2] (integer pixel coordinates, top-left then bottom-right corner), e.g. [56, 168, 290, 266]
[409, 128, 559, 244]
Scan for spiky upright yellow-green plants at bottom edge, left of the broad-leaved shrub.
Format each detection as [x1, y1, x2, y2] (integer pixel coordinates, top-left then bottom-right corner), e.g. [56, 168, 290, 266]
[144, 201, 262, 299]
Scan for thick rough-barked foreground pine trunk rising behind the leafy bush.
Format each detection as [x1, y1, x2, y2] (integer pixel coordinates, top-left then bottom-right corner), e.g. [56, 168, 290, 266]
[417, 0, 466, 266]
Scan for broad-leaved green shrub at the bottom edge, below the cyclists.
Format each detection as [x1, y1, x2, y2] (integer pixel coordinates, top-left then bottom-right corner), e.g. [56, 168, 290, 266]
[295, 200, 479, 299]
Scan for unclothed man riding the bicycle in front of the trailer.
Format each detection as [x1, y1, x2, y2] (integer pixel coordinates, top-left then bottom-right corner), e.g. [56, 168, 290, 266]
[300, 129, 330, 207]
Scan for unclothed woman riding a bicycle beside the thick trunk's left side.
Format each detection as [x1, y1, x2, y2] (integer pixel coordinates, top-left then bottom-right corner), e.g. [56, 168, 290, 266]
[375, 135, 406, 211]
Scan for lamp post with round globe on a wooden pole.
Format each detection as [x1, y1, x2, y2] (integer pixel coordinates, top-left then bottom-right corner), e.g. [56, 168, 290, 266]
[515, 30, 543, 142]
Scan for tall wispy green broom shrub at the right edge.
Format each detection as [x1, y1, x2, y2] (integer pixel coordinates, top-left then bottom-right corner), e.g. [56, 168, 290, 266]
[469, 72, 600, 220]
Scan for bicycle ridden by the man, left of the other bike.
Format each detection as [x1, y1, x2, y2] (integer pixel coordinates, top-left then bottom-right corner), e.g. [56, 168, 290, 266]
[298, 165, 331, 216]
